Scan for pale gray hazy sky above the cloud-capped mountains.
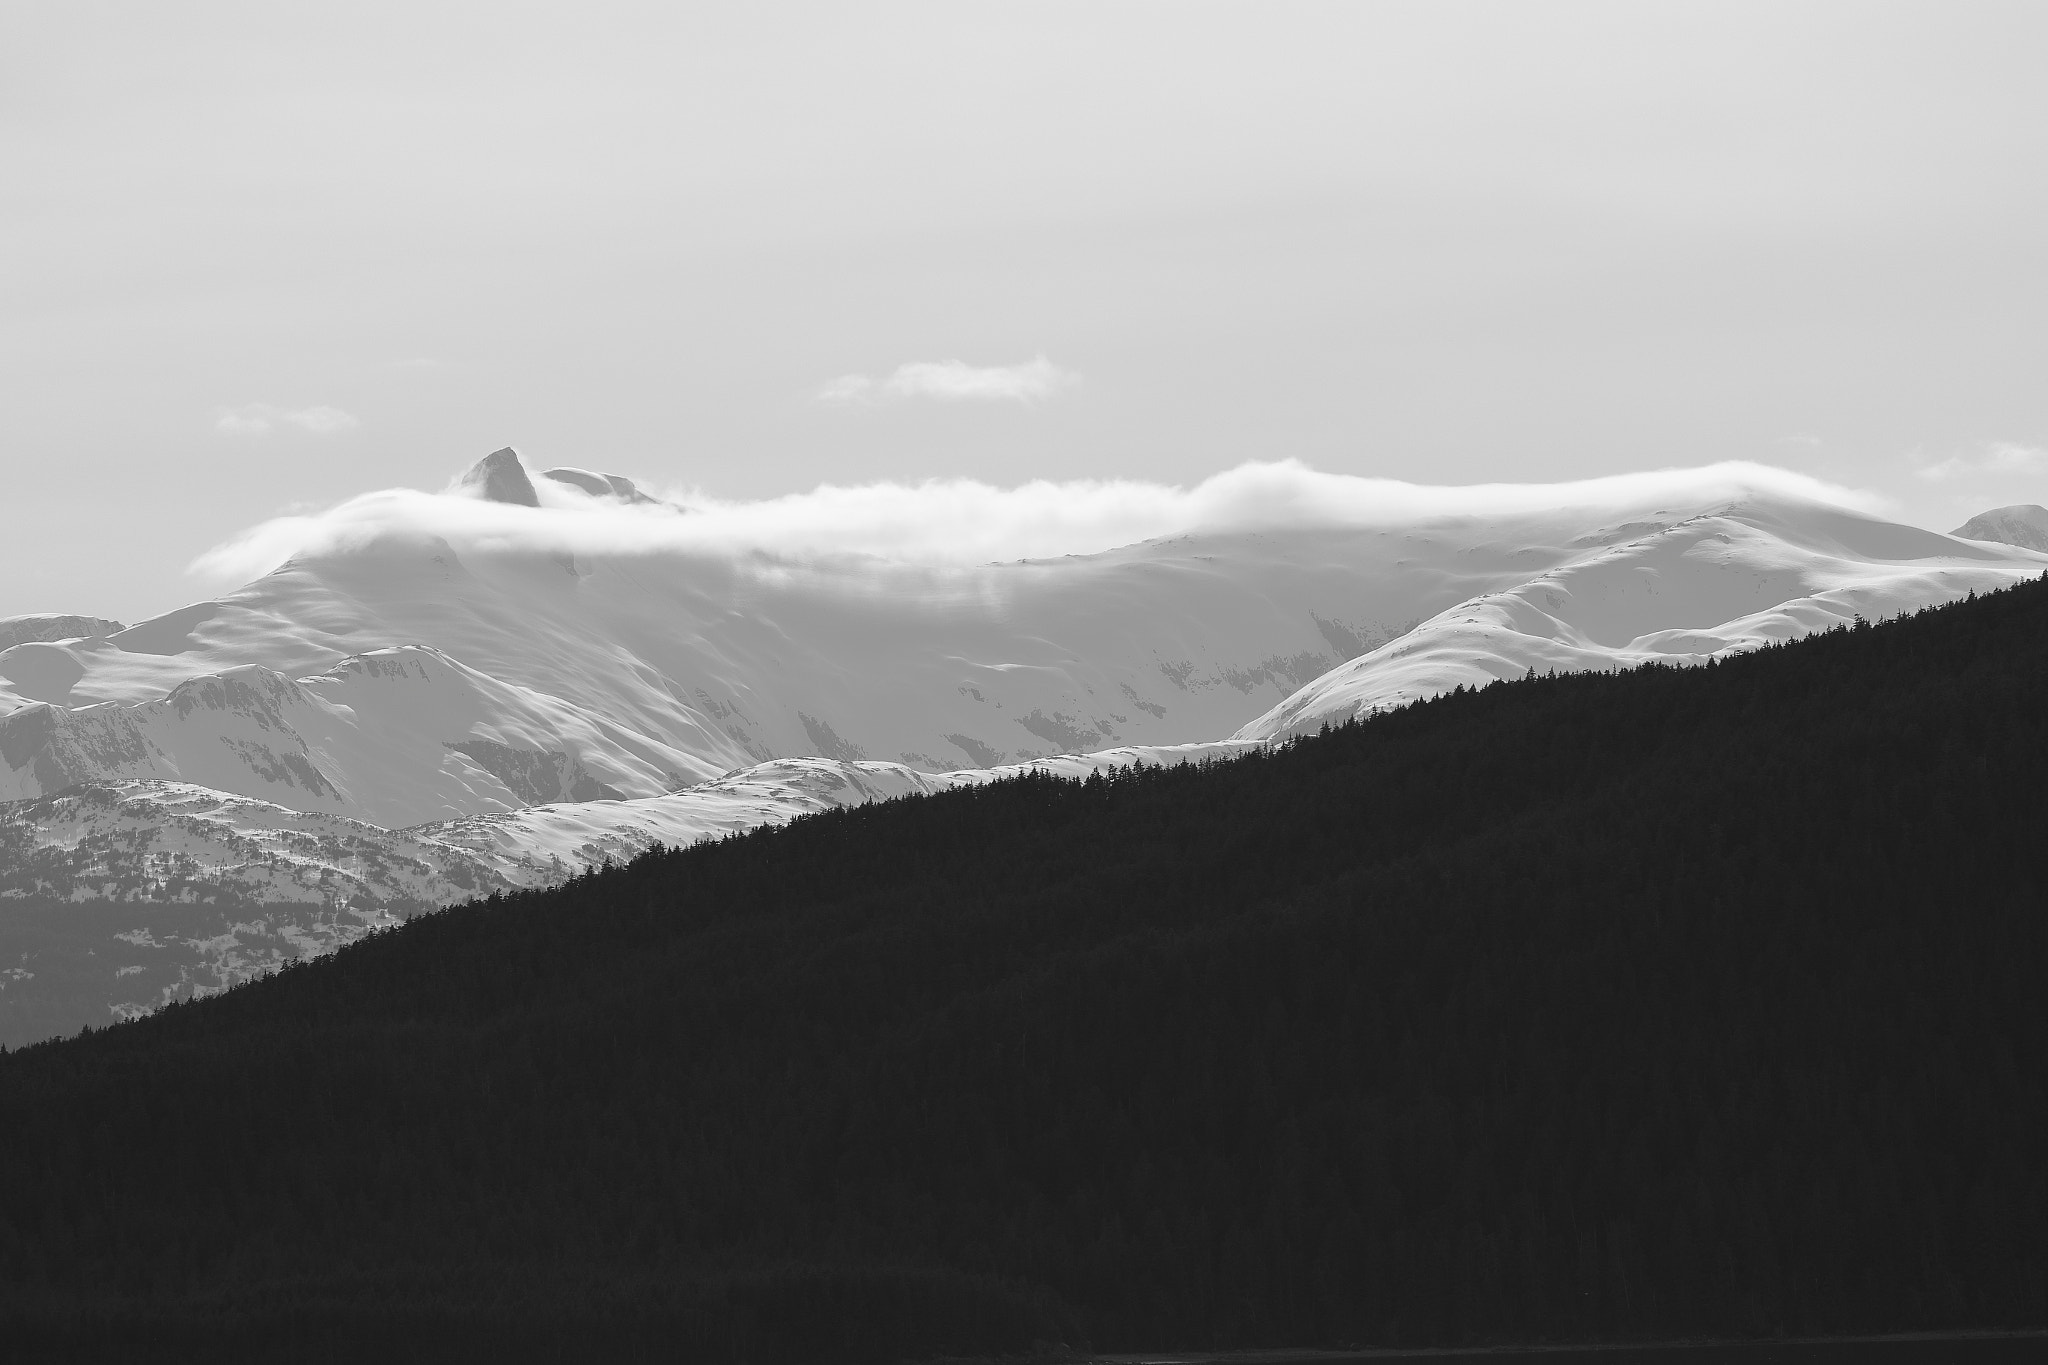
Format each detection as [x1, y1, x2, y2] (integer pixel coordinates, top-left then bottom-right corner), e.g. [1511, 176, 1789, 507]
[0, 0, 2048, 620]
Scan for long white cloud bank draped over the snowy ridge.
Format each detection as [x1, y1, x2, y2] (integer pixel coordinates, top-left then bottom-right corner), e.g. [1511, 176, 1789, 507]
[190, 460, 1882, 583]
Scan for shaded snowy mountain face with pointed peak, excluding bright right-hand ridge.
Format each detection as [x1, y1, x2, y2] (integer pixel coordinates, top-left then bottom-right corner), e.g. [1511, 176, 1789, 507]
[0, 452, 1599, 810]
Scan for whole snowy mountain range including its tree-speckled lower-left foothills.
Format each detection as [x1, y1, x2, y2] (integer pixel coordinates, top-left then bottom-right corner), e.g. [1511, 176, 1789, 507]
[0, 450, 2048, 1038]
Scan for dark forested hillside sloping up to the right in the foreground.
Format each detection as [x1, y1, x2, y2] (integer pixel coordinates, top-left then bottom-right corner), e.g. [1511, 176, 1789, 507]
[0, 583, 2048, 1361]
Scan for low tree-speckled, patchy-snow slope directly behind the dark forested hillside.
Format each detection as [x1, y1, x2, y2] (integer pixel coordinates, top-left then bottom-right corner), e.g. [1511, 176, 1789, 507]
[0, 741, 1253, 1048]
